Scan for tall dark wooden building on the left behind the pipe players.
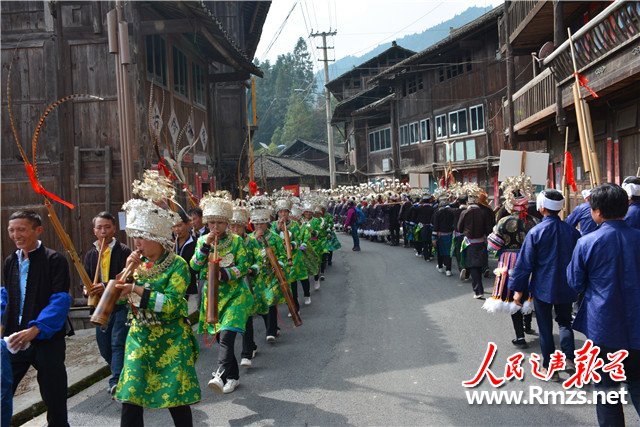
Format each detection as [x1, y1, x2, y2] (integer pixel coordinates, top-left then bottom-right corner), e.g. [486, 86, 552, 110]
[1, 1, 270, 296]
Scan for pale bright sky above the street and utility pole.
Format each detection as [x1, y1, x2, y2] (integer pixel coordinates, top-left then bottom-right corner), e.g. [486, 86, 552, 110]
[256, 0, 503, 70]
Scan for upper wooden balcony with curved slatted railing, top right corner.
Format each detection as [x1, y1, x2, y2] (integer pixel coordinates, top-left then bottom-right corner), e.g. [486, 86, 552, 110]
[544, 1, 640, 85]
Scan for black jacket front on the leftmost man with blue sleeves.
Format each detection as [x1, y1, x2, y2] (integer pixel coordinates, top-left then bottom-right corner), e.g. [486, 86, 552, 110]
[3, 245, 70, 338]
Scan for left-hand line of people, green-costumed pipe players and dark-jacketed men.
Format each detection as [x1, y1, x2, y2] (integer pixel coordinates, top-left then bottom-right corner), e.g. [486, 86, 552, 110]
[2, 171, 340, 426]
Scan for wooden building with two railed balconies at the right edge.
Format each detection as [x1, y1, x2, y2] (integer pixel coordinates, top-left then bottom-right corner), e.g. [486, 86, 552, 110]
[500, 1, 640, 205]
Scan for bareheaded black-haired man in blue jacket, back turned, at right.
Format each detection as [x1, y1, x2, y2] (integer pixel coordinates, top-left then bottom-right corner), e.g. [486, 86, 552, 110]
[567, 184, 640, 426]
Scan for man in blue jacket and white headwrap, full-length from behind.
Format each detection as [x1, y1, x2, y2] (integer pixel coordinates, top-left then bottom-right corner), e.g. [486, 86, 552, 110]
[509, 189, 580, 381]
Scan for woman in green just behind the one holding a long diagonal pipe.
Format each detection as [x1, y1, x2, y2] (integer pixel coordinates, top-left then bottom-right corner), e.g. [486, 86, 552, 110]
[271, 197, 311, 311]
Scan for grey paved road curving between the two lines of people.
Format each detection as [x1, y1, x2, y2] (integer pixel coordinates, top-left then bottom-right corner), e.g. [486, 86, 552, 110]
[23, 236, 639, 426]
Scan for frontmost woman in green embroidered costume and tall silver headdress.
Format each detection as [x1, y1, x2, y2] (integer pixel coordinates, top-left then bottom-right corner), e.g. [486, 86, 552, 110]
[115, 173, 200, 426]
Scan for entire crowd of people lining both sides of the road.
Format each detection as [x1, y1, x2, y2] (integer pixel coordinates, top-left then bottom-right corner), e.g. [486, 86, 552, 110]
[1, 171, 640, 426]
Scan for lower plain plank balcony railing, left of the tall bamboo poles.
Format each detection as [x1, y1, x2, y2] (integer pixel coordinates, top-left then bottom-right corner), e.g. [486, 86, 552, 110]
[505, 68, 556, 132]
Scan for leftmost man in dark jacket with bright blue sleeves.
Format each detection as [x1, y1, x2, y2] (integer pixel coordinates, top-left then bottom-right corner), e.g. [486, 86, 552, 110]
[3, 211, 71, 426]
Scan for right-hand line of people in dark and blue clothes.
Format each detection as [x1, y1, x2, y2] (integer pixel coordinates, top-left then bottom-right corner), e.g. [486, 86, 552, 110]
[329, 175, 640, 425]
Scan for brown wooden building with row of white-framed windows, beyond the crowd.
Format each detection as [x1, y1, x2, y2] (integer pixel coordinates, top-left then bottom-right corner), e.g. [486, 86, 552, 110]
[334, 8, 526, 202]
